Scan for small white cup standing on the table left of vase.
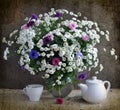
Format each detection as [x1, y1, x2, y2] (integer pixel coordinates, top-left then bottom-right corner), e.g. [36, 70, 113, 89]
[23, 84, 43, 101]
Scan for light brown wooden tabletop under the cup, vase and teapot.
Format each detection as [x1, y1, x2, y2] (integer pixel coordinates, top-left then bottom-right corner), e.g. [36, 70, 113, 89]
[0, 89, 120, 110]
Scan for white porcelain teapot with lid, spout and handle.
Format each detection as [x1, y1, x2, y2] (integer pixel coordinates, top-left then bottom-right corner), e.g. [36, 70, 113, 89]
[78, 76, 111, 103]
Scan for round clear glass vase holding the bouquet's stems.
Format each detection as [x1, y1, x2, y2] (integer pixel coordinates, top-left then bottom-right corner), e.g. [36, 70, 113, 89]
[49, 84, 73, 98]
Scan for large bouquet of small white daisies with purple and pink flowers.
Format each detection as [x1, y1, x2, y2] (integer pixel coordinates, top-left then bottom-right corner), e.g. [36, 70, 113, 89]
[3, 8, 117, 93]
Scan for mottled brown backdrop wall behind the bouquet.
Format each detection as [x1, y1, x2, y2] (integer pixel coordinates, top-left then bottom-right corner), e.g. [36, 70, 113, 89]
[0, 0, 120, 88]
